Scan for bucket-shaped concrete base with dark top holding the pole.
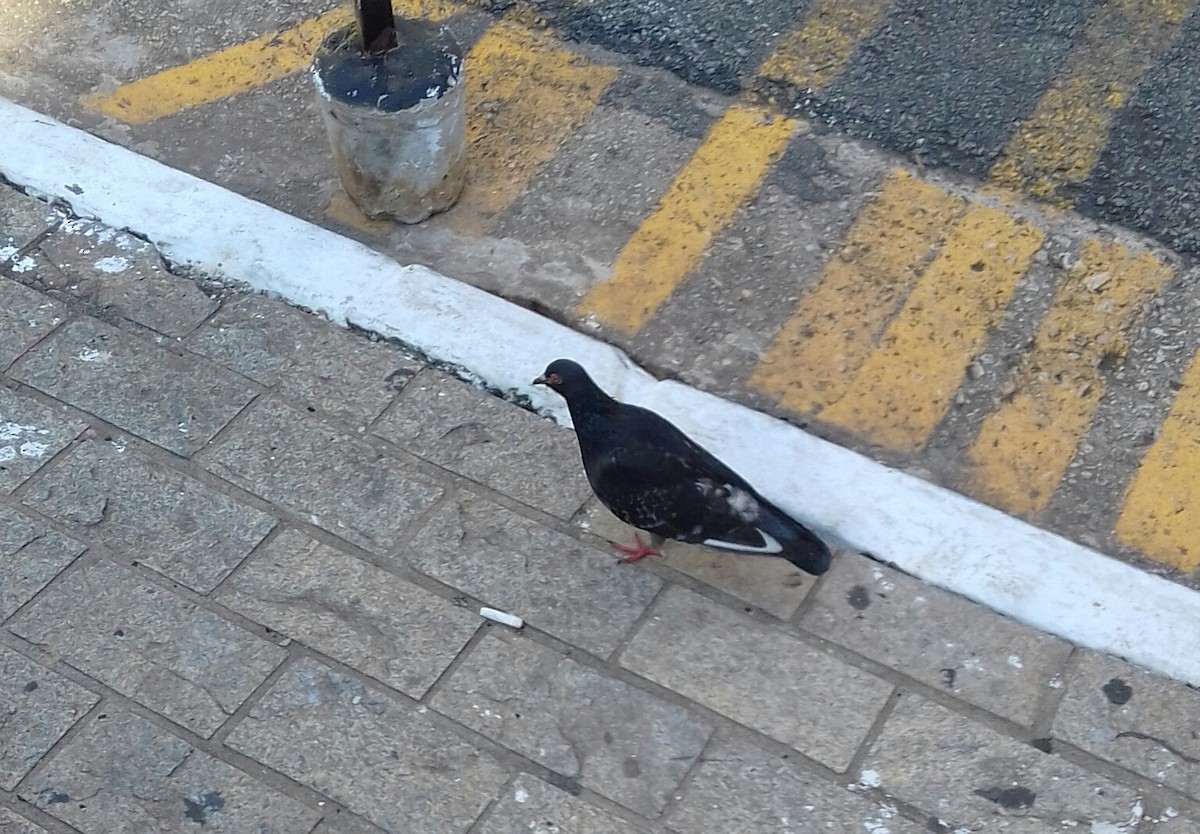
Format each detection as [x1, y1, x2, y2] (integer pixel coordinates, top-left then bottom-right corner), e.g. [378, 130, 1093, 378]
[312, 19, 467, 223]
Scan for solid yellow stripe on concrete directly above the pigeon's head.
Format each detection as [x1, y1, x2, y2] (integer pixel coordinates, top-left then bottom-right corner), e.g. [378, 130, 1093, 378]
[577, 104, 796, 334]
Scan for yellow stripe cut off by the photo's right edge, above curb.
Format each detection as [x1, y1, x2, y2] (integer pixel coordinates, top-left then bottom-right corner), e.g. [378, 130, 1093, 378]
[1116, 355, 1200, 570]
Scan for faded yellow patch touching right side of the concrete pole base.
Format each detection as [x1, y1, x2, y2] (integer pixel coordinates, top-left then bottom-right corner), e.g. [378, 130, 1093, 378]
[451, 20, 617, 232]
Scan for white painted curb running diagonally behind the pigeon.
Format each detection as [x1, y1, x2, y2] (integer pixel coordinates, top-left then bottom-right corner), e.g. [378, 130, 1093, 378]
[0, 100, 1200, 685]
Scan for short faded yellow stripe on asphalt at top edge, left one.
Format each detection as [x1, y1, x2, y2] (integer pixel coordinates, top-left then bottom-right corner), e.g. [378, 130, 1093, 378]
[758, 0, 893, 90]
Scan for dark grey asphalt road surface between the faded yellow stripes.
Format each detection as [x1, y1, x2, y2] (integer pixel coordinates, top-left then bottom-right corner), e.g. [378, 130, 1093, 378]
[475, 0, 1200, 256]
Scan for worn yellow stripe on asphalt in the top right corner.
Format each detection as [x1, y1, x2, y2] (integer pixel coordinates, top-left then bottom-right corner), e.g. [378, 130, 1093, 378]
[989, 0, 1196, 205]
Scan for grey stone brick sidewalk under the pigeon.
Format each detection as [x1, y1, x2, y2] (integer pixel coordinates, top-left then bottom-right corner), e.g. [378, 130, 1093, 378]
[0, 186, 1200, 834]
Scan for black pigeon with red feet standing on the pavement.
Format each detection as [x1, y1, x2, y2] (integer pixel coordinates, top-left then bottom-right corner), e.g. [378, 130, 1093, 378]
[533, 359, 829, 576]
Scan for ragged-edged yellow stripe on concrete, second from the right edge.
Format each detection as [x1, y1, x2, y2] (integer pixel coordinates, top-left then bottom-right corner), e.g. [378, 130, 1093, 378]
[968, 240, 1171, 512]
